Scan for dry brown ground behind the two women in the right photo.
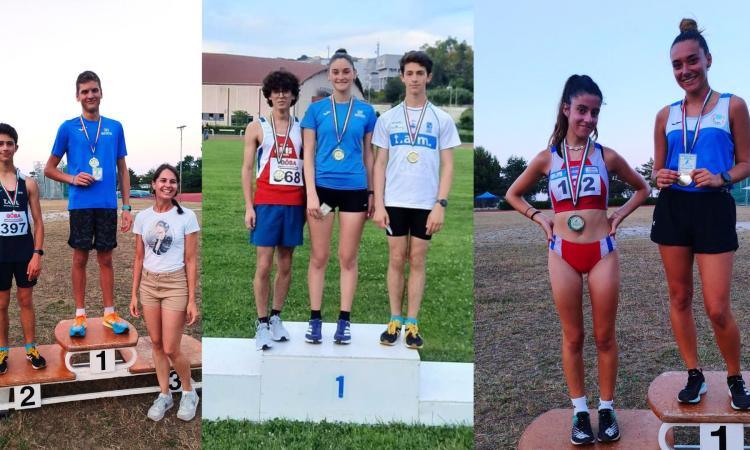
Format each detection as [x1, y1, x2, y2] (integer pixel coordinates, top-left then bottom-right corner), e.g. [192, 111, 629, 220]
[474, 207, 750, 449]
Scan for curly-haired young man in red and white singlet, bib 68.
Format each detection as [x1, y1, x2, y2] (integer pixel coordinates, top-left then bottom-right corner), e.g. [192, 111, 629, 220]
[242, 70, 305, 350]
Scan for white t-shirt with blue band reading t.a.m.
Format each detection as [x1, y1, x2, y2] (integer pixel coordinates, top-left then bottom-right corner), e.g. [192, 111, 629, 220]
[372, 102, 461, 209]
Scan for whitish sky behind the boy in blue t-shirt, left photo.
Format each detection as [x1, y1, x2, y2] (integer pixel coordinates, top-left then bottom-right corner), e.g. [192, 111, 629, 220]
[0, 0, 201, 174]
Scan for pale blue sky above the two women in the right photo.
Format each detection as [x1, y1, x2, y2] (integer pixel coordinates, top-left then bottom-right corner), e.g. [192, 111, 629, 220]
[474, 0, 750, 167]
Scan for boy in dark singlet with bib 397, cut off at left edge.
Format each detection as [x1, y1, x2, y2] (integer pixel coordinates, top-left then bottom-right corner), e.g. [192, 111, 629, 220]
[0, 123, 47, 374]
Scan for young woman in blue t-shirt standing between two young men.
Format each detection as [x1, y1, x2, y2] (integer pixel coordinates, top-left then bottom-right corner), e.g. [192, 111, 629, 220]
[301, 50, 376, 344]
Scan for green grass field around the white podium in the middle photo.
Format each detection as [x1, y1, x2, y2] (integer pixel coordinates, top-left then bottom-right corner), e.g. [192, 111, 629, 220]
[203, 141, 474, 448]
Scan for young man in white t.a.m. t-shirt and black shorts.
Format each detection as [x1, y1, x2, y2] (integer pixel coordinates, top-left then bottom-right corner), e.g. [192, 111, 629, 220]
[372, 51, 461, 349]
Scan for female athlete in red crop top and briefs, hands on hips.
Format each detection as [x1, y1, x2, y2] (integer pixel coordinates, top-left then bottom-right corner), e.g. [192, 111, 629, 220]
[505, 75, 649, 444]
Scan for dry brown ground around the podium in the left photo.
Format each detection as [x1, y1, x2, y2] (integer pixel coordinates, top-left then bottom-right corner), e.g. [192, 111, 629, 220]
[0, 199, 201, 449]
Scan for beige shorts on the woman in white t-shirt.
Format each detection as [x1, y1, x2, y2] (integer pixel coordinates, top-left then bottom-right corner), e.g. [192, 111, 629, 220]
[140, 268, 188, 311]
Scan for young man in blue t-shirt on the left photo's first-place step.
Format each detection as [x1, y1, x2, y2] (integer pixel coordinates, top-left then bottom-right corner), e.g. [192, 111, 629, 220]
[44, 71, 133, 336]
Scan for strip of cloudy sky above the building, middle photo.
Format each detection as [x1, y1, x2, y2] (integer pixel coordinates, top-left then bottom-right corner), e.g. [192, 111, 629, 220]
[203, 0, 474, 59]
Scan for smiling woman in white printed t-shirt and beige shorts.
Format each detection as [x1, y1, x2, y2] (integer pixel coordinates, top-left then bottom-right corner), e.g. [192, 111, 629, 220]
[130, 164, 200, 421]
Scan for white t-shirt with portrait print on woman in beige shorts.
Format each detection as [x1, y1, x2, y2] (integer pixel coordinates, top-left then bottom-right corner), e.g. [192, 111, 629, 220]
[133, 207, 200, 273]
